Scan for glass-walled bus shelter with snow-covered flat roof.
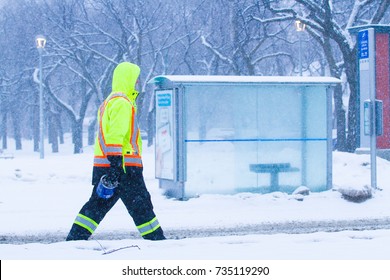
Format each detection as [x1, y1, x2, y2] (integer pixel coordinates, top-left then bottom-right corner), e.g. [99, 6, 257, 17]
[149, 75, 340, 199]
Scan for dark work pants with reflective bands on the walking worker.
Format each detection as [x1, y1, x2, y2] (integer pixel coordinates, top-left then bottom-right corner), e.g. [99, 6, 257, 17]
[67, 167, 163, 240]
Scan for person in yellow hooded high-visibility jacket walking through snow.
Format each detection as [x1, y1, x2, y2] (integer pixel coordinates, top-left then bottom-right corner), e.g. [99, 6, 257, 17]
[66, 62, 165, 241]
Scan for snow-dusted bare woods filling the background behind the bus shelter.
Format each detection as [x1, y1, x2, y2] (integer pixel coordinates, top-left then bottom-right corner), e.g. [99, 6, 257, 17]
[0, 0, 389, 153]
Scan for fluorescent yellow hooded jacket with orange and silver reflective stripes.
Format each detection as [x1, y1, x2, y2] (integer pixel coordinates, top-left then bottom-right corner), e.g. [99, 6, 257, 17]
[93, 62, 142, 174]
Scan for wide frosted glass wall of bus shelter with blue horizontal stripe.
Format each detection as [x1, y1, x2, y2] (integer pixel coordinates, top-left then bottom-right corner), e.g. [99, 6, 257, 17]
[185, 85, 327, 195]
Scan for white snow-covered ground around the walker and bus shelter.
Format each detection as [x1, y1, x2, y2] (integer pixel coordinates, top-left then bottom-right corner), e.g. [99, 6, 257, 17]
[0, 135, 390, 266]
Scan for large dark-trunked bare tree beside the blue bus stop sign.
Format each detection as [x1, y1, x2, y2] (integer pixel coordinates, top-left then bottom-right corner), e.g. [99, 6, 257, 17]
[262, 0, 390, 152]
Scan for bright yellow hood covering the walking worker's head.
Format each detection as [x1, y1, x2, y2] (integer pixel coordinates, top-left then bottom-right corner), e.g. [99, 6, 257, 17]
[112, 62, 140, 101]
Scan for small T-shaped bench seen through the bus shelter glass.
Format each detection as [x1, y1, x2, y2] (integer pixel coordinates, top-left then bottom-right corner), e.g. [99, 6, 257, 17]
[249, 163, 299, 191]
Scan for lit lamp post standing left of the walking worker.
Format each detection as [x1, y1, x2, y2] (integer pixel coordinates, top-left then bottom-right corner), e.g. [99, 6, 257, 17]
[35, 35, 46, 159]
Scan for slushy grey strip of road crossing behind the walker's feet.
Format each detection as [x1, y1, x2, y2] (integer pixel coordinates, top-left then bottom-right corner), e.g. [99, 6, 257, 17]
[0, 217, 390, 244]
